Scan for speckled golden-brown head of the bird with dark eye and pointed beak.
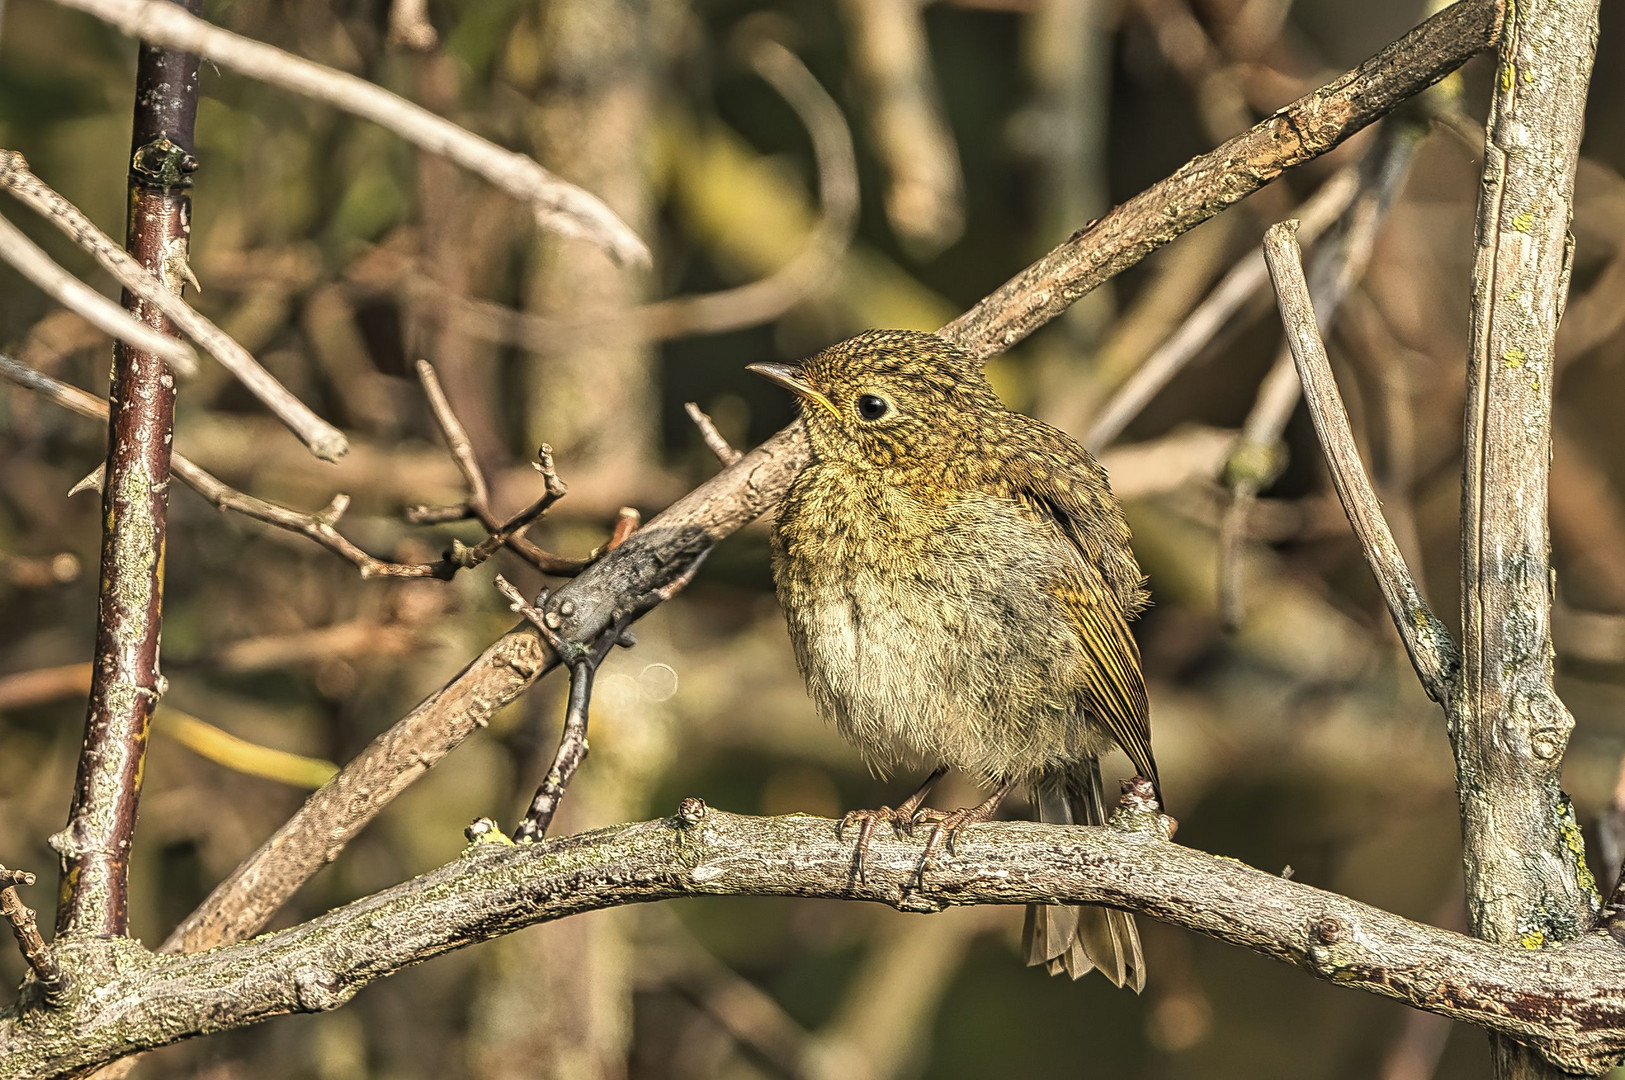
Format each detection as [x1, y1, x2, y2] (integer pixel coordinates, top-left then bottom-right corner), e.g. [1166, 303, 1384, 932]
[749, 330, 1004, 469]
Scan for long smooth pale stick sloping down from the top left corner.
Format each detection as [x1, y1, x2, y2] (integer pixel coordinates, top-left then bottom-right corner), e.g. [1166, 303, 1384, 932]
[42, 0, 650, 266]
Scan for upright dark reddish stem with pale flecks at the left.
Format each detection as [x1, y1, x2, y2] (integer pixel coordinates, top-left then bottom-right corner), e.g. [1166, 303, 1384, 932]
[54, 0, 203, 935]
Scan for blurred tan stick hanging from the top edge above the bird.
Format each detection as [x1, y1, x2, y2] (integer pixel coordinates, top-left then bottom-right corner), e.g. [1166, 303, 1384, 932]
[839, 0, 965, 252]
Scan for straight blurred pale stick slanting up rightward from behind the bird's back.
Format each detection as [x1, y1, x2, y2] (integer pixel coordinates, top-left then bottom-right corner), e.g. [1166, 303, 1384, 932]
[1084, 166, 1360, 453]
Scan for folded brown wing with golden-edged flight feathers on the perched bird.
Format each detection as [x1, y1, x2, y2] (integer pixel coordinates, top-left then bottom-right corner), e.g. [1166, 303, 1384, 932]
[1004, 421, 1160, 797]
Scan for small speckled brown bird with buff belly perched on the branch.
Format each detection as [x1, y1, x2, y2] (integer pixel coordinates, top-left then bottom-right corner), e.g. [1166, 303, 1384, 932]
[748, 330, 1162, 992]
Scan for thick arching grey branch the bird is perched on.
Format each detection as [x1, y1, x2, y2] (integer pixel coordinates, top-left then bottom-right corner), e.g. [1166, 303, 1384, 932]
[0, 799, 1625, 1080]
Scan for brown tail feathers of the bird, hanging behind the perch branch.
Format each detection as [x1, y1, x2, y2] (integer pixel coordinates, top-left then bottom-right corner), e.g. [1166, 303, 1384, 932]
[1022, 757, 1146, 994]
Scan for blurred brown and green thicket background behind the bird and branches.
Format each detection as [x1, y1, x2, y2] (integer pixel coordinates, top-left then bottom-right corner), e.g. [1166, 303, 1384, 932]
[0, 0, 1625, 1080]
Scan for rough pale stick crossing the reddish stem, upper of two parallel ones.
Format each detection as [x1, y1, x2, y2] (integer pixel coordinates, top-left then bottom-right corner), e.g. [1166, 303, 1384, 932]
[0, 149, 349, 461]
